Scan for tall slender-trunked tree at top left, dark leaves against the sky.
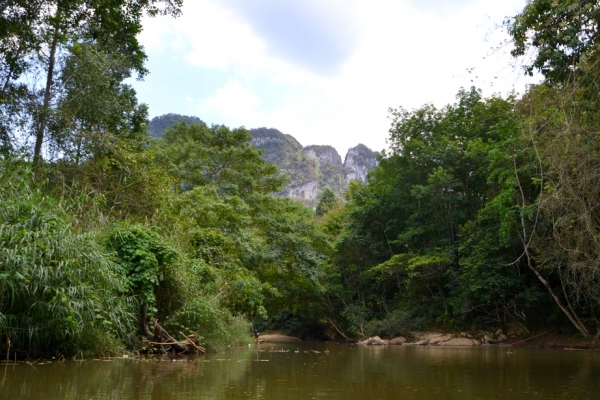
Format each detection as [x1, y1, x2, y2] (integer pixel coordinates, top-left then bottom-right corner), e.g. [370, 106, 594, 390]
[0, 0, 182, 163]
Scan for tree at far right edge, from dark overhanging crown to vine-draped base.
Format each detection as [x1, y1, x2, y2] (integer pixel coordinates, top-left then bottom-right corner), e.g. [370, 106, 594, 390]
[509, 0, 600, 336]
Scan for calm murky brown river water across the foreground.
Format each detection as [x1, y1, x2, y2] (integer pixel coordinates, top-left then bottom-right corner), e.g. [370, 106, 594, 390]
[0, 343, 600, 400]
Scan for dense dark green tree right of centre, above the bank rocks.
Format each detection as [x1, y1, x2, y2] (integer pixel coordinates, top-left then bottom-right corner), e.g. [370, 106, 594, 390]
[328, 89, 548, 335]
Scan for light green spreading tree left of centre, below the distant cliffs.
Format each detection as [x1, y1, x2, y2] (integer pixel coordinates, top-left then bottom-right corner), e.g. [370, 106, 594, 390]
[156, 123, 327, 324]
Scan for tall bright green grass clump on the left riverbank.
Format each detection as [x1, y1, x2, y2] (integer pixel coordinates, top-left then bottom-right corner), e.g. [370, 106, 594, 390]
[0, 162, 135, 356]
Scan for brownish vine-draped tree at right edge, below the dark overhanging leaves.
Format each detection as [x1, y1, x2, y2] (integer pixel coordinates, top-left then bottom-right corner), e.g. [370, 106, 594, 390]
[510, 82, 600, 336]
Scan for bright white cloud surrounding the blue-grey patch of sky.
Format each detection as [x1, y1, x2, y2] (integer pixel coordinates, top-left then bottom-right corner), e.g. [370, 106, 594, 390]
[136, 0, 526, 157]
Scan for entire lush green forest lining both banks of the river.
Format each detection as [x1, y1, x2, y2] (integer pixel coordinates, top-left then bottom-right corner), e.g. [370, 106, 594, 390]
[0, 0, 600, 358]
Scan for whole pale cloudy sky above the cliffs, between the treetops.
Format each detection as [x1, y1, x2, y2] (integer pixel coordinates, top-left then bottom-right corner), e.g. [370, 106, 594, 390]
[131, 0, 533, 157]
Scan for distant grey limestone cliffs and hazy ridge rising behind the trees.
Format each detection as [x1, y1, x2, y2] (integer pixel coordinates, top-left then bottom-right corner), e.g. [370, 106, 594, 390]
[148, 114, 378, 207]
